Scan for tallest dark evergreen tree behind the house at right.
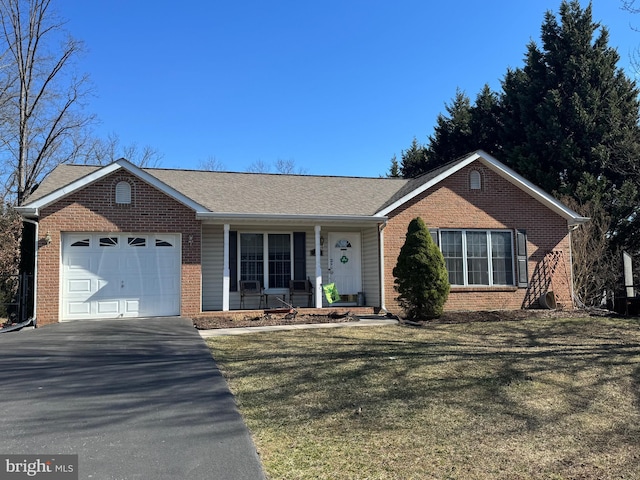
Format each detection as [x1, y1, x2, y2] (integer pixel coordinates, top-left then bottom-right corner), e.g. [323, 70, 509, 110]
[500, 0, 640, 251]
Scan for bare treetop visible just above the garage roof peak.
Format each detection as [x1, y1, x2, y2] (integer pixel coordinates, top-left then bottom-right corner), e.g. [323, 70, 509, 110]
[76, 133, 163, 168]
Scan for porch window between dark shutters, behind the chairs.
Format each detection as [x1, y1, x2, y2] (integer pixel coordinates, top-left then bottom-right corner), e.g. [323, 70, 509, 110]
[239, 233, 292, 288]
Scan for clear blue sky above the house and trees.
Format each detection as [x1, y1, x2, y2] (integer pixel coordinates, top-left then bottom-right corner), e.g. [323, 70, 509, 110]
[53, 0, 640, 177]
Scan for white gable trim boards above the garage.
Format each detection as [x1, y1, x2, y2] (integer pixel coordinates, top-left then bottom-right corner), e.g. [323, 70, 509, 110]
[17, 159, 207, 217]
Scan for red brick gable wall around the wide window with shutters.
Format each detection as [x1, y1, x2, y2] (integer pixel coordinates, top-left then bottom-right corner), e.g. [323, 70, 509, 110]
[384, 162, 572, 312]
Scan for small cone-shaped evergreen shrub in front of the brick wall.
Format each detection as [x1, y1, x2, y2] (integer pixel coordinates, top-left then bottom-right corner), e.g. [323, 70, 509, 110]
[393, 217, 450, 319]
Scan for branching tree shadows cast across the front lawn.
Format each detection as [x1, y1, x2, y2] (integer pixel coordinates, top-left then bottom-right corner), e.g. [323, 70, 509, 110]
[210, 319, 640, 462]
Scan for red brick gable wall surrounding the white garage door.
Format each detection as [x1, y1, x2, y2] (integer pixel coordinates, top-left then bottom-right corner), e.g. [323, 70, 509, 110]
[37, 171, 201, 325]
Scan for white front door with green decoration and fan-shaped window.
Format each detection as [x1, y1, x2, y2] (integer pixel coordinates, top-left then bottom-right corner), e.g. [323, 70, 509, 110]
[328, 232, 362, 295]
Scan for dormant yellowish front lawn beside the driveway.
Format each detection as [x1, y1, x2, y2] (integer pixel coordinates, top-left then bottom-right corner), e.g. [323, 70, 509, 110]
[208, 318, 640, 480]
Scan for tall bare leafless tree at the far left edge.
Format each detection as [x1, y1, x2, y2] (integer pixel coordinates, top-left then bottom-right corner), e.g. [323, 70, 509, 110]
[0, 0, 93, 205]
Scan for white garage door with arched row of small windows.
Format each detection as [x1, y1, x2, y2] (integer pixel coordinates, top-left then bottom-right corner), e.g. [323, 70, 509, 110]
[62, 233, 180, 320]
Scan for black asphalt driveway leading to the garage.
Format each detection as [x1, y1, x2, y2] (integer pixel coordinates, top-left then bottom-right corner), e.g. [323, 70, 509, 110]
[0, 318, 264, 480]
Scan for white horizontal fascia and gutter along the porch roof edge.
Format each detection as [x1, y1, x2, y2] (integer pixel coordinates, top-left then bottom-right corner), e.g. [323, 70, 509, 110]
[196, 212, 388, 225]
